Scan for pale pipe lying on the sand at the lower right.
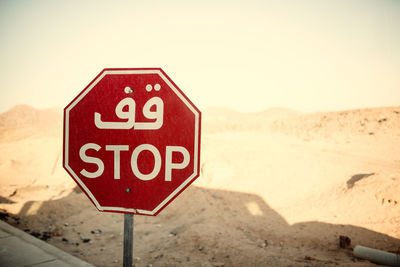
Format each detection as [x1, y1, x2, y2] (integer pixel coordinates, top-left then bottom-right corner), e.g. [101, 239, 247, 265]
[353, 245, 400, 267]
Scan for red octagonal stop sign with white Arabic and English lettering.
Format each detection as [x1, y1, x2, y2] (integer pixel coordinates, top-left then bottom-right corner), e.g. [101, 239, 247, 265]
[63, 68, 201, 215]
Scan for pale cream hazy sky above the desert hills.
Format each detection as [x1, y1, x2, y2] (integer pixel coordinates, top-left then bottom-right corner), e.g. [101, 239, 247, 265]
[0, 0, 400, 112]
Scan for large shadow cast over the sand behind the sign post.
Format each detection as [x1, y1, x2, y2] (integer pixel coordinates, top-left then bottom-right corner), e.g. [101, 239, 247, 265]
[3, 185, 400, 266]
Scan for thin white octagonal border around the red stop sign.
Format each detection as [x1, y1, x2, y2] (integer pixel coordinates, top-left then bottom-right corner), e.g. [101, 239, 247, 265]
[64, 69, 200, 215]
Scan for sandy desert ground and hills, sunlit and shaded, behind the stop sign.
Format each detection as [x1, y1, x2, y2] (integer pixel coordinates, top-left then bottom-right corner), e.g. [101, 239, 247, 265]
[0, 106, 400, 266]
